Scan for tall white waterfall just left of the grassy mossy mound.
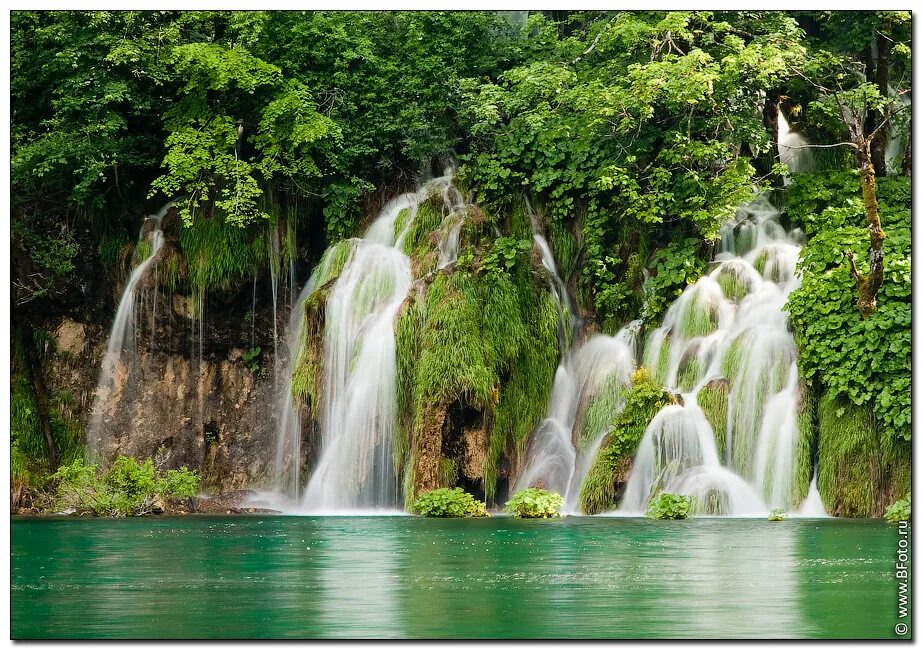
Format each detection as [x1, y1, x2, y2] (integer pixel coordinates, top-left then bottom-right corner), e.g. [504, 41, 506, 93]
[276, 175, 463, 512]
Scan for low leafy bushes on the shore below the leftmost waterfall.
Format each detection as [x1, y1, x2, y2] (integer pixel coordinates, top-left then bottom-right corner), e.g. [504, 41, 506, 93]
[48, 456, 199, 517]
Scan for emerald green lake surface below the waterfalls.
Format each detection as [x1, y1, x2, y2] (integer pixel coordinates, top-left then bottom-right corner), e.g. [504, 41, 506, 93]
[11, 516, 909, 639]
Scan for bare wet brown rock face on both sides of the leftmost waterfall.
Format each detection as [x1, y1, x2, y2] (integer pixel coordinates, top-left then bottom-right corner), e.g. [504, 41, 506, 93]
[44, 318, 275, 492]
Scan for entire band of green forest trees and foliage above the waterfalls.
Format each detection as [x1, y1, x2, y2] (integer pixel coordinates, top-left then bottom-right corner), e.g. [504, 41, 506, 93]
[11, 11, 912, 516]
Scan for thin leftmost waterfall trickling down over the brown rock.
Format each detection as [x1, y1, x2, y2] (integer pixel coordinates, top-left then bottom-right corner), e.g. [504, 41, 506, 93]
[87, 202, 172, 459]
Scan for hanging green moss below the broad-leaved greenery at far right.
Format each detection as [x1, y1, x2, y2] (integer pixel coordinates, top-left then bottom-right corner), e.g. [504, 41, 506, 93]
[817, 394, 880, 517]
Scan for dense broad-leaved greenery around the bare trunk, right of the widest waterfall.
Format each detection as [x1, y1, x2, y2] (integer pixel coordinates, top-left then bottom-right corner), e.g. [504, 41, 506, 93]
[787, 172, 912, 440]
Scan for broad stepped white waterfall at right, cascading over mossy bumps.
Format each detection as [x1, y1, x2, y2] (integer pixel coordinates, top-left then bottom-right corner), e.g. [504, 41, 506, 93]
[621, 196, 822, 515]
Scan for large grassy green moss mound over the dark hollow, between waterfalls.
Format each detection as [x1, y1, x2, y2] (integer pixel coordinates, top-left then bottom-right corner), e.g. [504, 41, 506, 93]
[396, 256, 557, 498]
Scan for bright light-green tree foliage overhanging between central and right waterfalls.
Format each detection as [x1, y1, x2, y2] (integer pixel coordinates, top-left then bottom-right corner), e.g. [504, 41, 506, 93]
[462, 12, 805, 330]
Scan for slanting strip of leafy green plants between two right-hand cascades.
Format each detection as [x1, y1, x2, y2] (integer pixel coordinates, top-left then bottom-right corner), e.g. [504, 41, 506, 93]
[579, 368, 672, 515]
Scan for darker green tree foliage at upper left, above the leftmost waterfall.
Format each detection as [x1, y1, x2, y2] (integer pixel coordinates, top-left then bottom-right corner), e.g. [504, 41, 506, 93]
[11, 11, 520, 301]
